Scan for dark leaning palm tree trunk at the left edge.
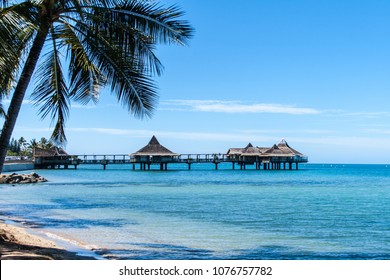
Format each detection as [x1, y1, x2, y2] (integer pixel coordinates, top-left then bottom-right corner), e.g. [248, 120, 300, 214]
[0, 24, 49, 173]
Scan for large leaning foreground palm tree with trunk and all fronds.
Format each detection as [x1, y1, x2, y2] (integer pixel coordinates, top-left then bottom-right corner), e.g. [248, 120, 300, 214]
[0, 0, 193, 172]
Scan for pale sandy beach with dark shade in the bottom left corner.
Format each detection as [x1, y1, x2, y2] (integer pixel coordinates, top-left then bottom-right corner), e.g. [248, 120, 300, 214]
[0, 221, 94, 260]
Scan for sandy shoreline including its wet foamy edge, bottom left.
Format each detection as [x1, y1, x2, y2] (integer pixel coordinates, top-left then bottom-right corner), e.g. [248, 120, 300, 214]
[0, 217, 104, 260]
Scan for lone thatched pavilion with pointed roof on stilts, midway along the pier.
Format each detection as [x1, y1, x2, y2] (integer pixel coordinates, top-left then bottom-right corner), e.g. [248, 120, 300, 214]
[130, 135, 180, 170]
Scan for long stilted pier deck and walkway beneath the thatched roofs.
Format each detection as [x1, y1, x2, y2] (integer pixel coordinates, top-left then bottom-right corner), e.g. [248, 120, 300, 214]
[34, 154, 308, 170]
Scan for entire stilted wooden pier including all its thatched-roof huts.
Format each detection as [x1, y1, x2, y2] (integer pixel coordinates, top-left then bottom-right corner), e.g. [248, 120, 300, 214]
[34, 136, 308, 170]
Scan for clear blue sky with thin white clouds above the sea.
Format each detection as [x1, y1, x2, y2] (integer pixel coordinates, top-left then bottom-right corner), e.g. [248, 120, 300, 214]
[4, 0, 390, 163]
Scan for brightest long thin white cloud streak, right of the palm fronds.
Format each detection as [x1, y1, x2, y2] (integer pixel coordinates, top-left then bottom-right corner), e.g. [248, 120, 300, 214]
[161, 100, 321, 115]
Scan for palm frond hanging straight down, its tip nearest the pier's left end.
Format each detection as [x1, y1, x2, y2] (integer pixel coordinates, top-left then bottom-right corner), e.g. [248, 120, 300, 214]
[32, 35, 69, 144]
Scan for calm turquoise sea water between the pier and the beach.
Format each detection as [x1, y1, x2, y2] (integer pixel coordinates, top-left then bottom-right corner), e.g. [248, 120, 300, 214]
[0, 164, 390, 259]
